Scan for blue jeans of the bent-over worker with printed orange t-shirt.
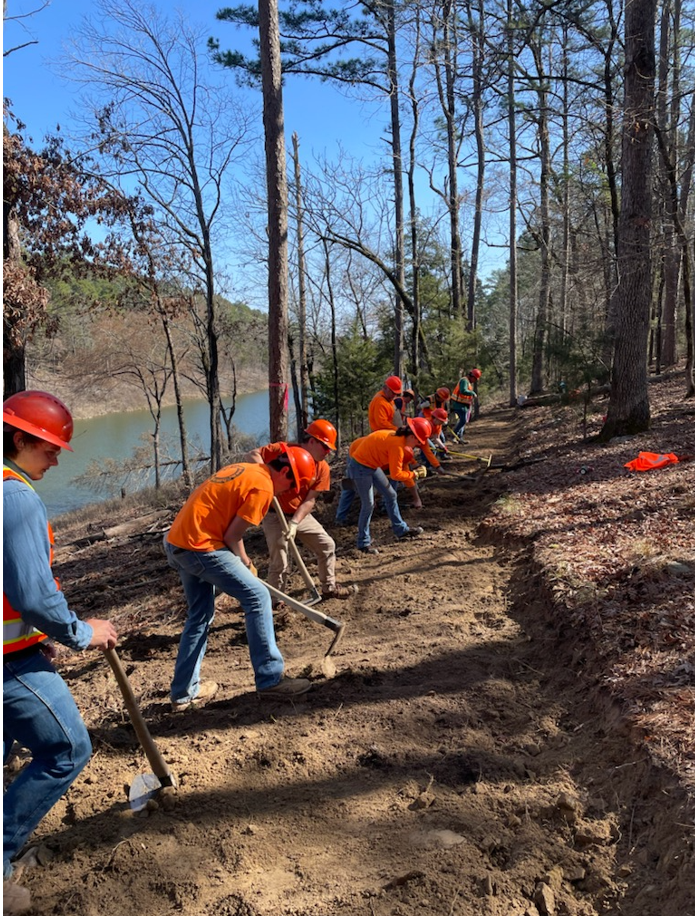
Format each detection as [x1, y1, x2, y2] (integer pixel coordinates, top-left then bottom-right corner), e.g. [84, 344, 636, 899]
[164, 535, 285, 703]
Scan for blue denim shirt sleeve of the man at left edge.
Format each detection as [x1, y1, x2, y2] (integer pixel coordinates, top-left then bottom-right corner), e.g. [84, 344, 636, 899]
[2, 459, 93, 649]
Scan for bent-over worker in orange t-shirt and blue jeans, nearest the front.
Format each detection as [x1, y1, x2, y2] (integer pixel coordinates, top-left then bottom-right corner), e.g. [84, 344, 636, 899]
[164, 446, 316, 712]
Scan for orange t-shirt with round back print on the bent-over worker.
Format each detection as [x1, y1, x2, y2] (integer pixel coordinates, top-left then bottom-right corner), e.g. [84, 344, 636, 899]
[167, 464, 275, 553]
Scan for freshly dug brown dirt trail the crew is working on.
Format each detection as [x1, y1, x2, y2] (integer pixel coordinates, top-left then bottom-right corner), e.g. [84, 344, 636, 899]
[10, 411, 695, 916]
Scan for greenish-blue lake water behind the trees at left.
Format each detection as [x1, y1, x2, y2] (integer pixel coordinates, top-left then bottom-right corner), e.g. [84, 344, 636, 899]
[35, 391, 270, 518]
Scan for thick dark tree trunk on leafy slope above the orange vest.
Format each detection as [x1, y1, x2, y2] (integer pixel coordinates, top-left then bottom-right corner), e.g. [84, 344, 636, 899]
[601, 0, 656, 441]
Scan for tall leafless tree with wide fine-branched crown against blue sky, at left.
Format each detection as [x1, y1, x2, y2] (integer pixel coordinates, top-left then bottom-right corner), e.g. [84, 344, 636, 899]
[69, 0, 252, 470]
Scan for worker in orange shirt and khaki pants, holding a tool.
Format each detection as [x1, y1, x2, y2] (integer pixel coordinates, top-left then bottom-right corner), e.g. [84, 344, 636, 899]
[247, 419, 354, 600]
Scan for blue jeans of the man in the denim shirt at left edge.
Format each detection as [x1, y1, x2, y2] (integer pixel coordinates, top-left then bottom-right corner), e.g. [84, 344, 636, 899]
[2, 652, 92, 878]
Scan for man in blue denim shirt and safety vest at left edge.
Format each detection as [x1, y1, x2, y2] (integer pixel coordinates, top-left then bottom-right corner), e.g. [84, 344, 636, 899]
[2, 391, 118, 916]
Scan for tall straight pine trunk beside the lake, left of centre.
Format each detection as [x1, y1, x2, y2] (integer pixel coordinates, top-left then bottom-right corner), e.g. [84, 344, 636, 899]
[258, 0, 289, 442]
